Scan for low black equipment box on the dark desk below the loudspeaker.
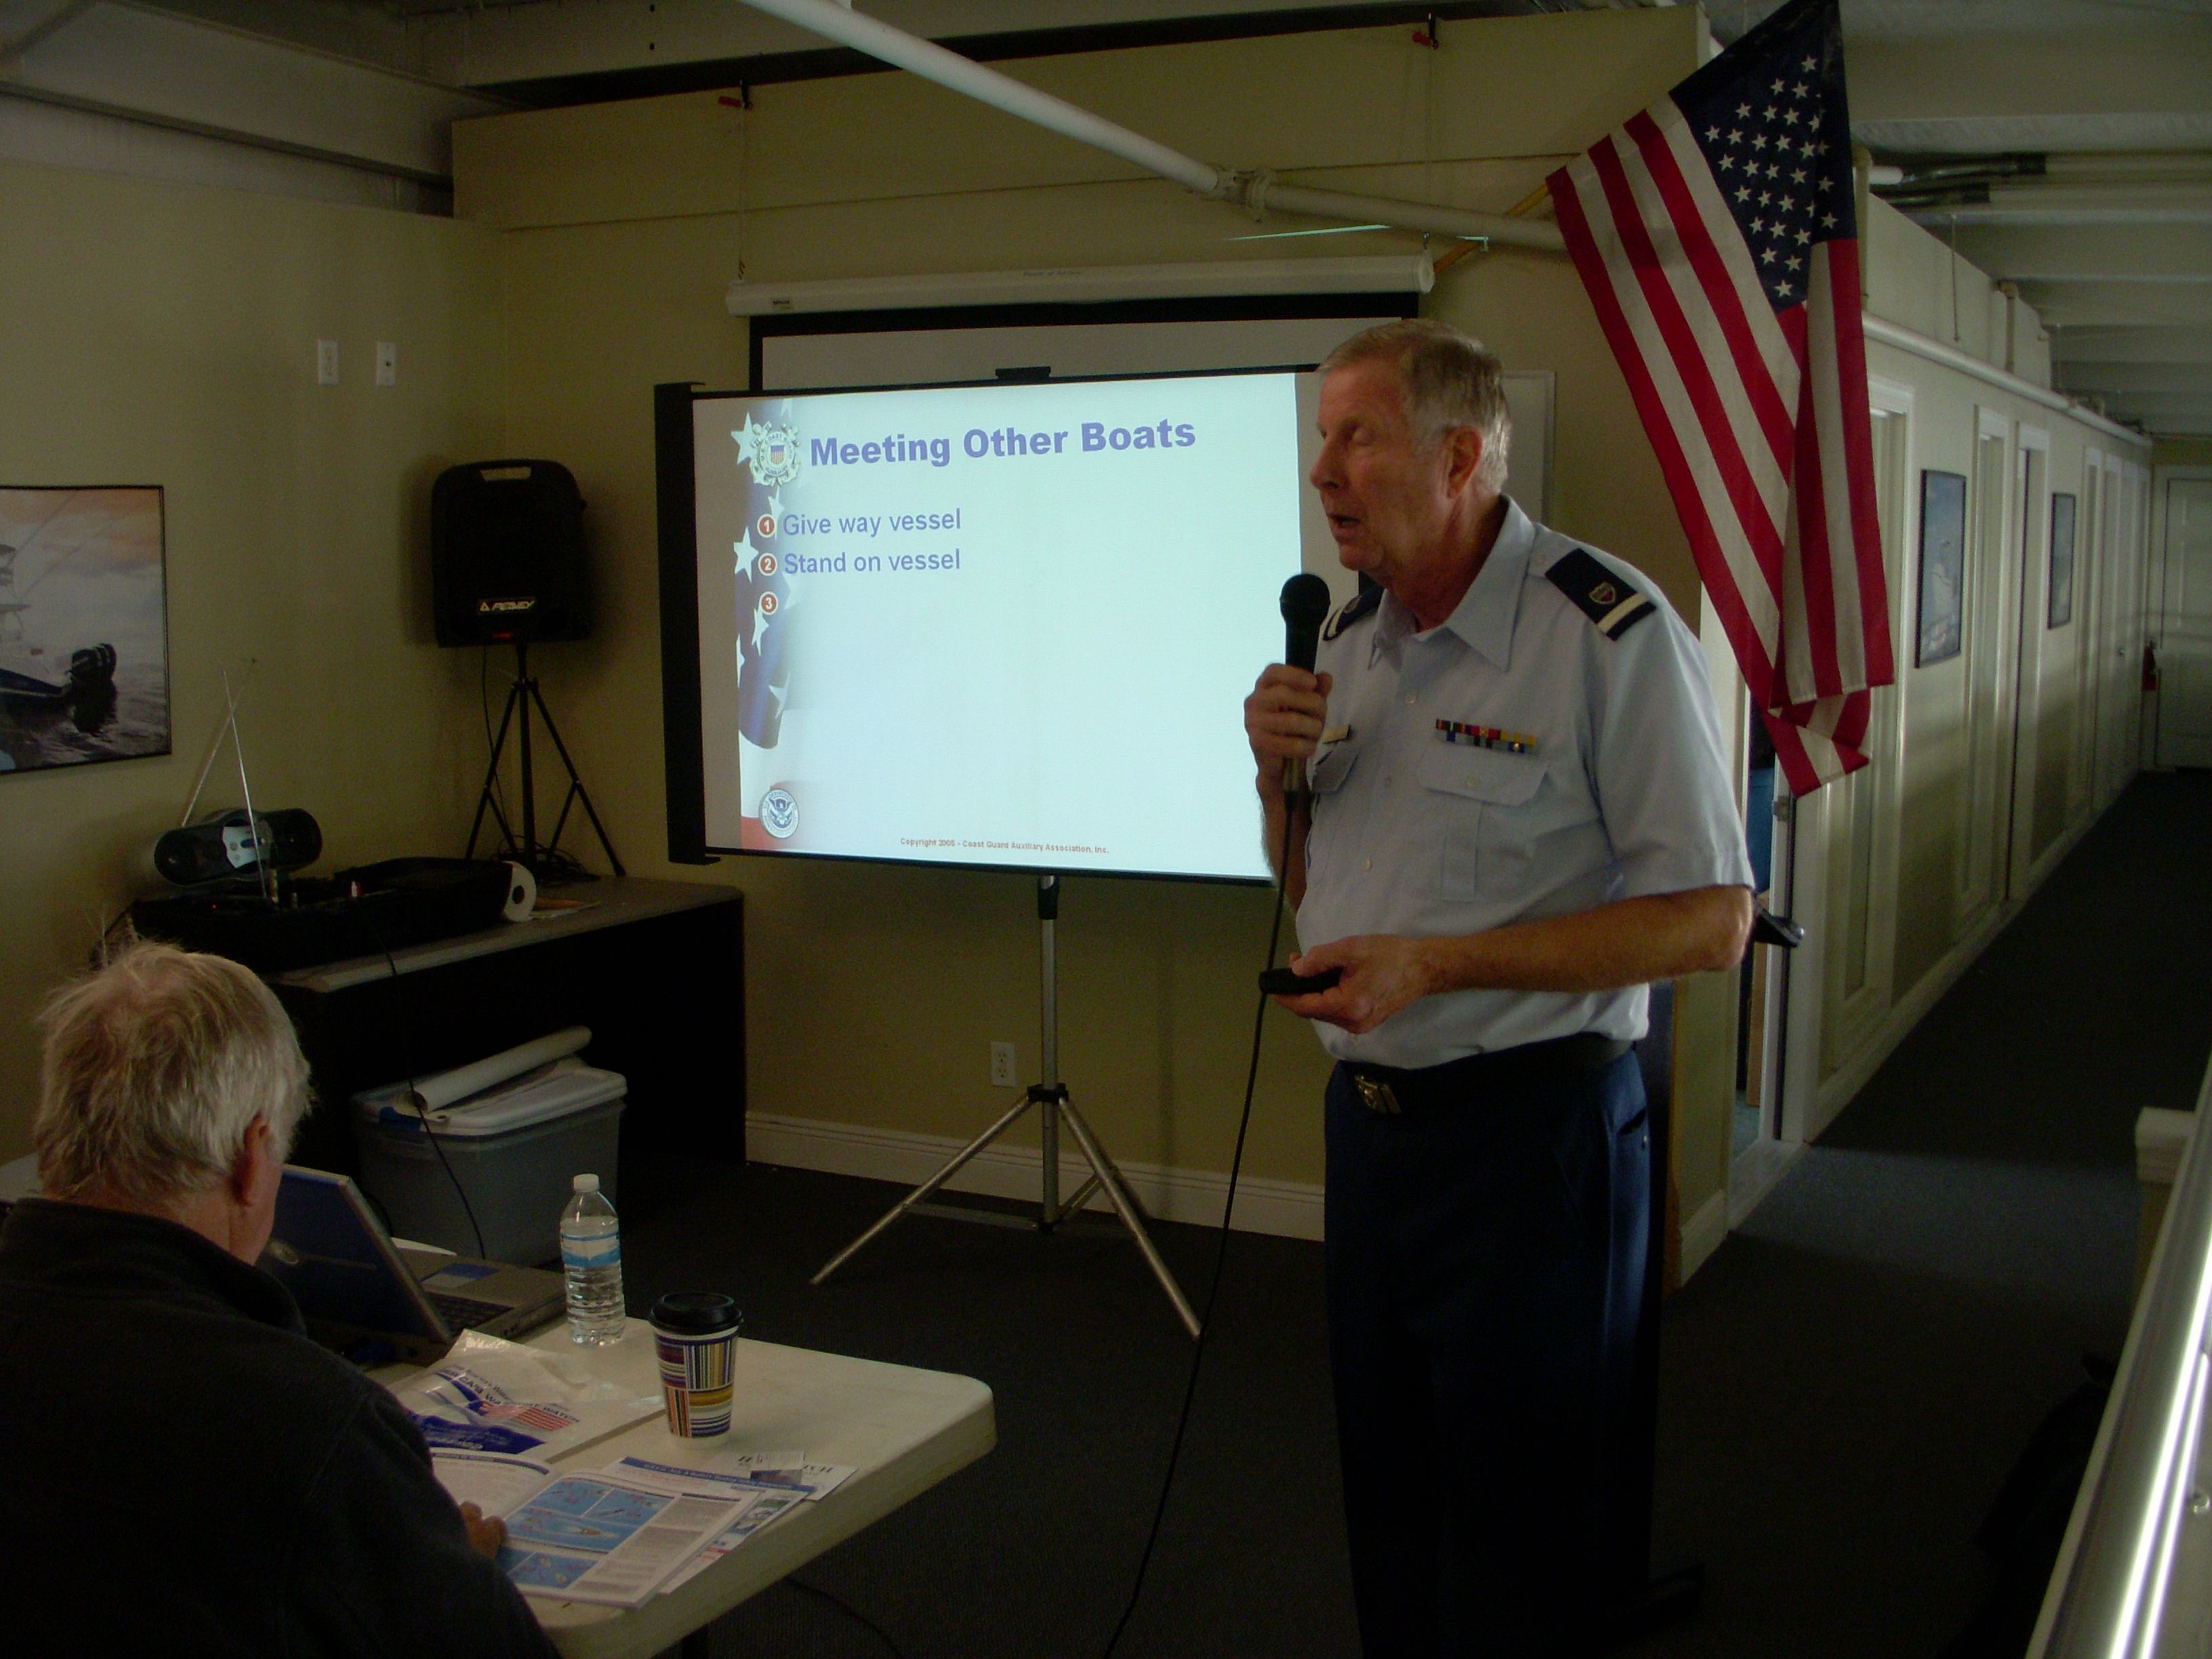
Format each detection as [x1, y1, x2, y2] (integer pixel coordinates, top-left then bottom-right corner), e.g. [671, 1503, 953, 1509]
[131, 858, 509, 973]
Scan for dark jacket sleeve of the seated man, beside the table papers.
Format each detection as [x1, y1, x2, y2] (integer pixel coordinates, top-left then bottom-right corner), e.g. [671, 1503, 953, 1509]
[287, 1389, 553, 1659]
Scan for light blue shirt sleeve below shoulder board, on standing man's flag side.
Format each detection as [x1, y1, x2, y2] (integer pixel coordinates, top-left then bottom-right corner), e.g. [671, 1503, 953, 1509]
[1591, 602, 1752, 898]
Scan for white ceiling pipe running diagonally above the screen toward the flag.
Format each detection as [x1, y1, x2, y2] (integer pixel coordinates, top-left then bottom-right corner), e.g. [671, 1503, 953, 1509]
[745, 0, 1566, 252]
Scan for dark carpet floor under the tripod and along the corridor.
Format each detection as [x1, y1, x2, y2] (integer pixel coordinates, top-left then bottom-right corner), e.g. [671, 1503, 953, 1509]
[621, 774, 2212, 1659]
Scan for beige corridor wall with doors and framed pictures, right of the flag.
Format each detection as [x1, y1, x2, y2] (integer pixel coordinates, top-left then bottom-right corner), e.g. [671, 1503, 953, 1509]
[1792, 203, 2150, 1132]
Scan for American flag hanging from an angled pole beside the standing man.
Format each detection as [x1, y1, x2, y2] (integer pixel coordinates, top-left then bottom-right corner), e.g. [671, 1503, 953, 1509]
[1549, 0, 1896, 794]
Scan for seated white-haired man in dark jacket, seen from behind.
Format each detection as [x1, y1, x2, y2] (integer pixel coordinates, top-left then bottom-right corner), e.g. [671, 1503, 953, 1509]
[0, 945, 551, 1659]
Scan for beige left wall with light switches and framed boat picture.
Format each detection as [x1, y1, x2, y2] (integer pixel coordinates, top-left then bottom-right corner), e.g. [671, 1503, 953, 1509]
[0, 164, 500, 1157]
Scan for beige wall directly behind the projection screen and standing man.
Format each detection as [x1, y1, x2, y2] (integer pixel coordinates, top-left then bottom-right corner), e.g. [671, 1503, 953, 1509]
[455, 9, 1761, 1212]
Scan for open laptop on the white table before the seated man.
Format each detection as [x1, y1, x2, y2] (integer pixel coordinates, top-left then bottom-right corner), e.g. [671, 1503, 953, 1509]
[261, 1164, 564, 1365]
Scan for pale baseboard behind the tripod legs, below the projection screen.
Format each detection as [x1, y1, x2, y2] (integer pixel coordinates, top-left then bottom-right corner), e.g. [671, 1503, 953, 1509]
[745, 1113, 1321, 1239]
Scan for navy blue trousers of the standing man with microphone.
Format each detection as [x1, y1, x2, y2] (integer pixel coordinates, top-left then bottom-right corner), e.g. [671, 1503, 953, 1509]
[1325, 1053, 1650, 1659]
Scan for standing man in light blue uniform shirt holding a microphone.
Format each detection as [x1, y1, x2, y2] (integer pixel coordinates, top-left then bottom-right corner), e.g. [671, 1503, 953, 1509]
[1246, 321, 1752, 1659]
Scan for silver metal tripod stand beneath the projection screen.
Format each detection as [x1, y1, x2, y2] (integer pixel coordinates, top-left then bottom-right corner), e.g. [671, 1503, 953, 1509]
[812, 876, 1199, 1338]
